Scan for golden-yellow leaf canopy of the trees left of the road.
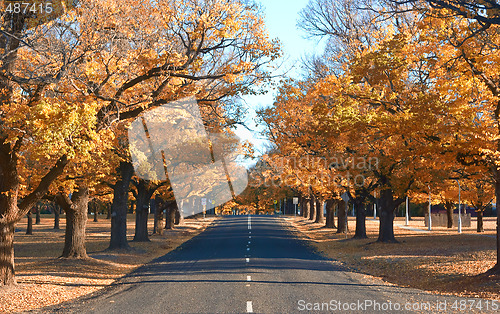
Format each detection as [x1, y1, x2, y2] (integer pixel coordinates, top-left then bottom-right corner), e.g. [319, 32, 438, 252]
[1, 0, 282, 200]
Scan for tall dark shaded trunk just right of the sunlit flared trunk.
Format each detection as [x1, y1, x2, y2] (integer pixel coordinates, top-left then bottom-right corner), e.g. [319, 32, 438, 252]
[108, 161, 134, 250]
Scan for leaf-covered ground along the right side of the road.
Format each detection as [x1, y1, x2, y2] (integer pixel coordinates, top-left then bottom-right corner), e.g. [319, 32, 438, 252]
[287, 217, 500, 300]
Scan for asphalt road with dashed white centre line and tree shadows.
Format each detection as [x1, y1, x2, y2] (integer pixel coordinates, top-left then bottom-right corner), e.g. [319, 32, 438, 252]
[45, 216, 500, 313]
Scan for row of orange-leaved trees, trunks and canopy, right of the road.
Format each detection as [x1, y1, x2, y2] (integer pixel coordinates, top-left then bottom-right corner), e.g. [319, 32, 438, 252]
[261, 0, 500, 273]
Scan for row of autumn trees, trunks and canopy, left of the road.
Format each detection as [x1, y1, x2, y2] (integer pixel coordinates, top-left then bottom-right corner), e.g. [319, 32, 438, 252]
[0, 0, 279, 285]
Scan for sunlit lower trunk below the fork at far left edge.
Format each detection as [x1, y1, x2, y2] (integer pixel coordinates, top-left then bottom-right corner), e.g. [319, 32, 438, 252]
[0, 223, 16, 286]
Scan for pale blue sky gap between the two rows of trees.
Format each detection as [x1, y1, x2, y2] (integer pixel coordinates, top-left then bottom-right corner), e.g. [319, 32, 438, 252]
[237, 0, 323, 157]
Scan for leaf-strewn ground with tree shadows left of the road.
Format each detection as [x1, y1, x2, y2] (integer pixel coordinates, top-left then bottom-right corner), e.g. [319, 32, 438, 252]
[0, 218, 214, 313]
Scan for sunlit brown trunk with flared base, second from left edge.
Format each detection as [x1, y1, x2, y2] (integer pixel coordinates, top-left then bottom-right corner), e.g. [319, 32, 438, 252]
[56, 184, 89, 258]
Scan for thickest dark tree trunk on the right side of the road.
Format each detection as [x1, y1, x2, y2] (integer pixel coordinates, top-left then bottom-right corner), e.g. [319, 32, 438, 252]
[377, 189, 399, 243]
